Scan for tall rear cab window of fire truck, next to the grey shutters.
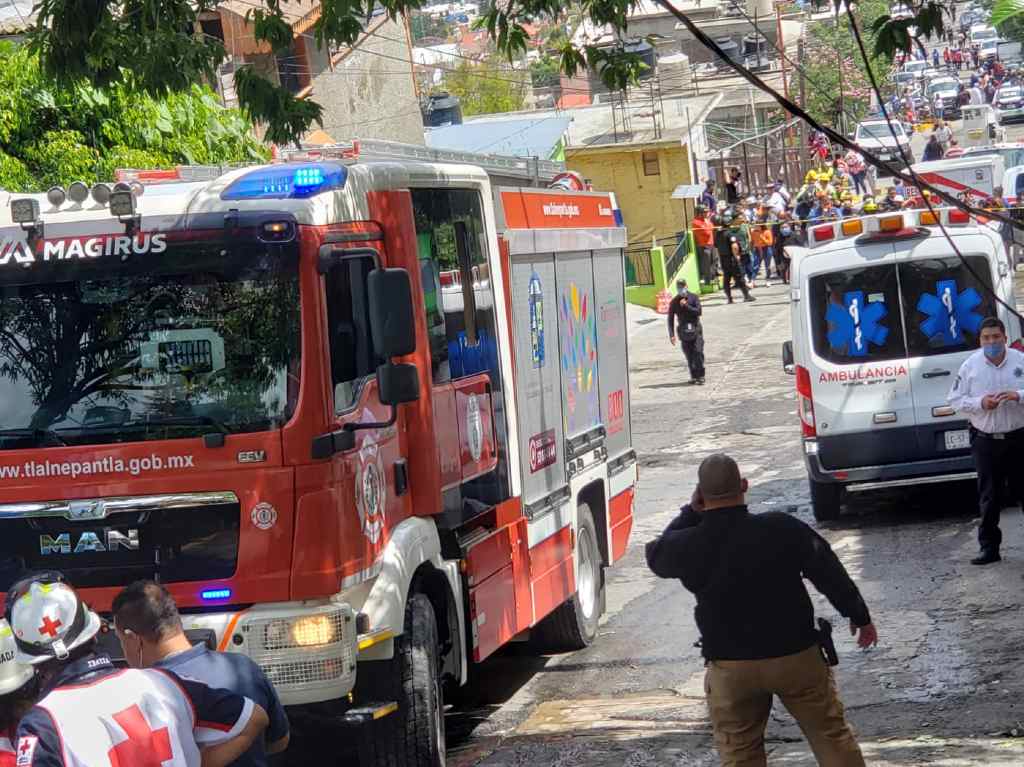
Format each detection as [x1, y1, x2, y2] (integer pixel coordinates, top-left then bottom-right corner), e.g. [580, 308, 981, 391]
[413, 189, 497, 383]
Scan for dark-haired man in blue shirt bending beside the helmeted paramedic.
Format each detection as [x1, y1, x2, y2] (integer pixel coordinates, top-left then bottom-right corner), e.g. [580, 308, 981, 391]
[111, 581, 290, 767]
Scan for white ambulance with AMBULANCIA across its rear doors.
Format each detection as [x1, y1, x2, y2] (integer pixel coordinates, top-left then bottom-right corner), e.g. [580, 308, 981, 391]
[782, 208, 1021, 520]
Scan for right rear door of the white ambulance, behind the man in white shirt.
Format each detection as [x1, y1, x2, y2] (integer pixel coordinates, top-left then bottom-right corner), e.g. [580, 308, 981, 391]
[897, 228, 1003, 460]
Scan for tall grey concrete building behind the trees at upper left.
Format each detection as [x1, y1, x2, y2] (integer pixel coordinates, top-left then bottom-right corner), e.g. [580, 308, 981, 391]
[201, 0, 423, 143]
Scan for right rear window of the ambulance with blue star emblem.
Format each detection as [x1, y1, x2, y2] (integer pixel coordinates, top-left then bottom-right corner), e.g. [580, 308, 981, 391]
[899, 256, 995, 356]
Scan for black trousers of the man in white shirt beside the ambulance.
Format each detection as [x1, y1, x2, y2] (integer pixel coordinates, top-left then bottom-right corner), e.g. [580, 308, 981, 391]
[971, 429, 1024, 552]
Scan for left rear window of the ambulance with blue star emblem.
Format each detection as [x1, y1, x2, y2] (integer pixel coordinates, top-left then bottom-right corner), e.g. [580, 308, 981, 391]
[810, 265, 906, 365]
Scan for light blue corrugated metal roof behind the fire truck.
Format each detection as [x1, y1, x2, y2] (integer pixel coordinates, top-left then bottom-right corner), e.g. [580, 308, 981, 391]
[424, 115, 569, 160]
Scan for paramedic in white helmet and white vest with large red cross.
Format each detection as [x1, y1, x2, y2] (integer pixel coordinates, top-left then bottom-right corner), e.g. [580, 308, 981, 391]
[7, 572, 267, 767]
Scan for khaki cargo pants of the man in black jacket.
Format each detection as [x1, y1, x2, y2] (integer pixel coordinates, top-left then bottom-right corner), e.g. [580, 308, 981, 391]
[705, 646, 864, 767]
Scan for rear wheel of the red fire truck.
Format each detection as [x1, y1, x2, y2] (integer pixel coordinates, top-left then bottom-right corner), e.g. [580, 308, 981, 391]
[530, 504, 604, 652]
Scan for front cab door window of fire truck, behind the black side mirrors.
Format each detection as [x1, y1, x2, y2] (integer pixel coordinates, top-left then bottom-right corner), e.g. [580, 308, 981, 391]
[326, 256, 381, 413]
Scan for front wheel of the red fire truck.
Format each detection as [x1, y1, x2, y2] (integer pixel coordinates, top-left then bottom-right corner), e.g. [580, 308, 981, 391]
[360, 593, 445, 767]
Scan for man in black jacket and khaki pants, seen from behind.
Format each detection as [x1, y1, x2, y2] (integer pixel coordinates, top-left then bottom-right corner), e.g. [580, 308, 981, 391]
[646, 453, 879, 767]
